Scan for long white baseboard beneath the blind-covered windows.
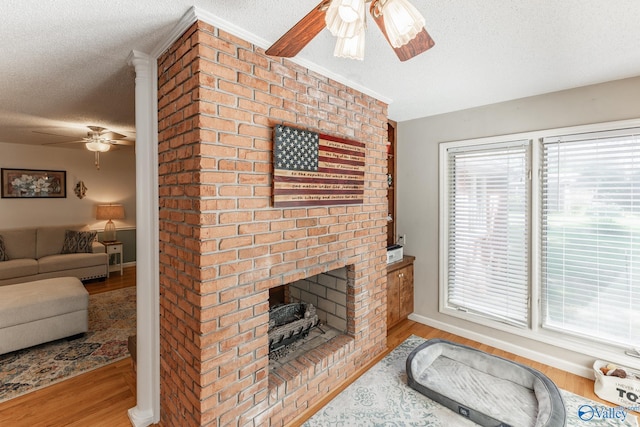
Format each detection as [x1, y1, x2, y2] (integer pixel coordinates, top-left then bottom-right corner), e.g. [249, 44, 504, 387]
[409, 313, 593, 379]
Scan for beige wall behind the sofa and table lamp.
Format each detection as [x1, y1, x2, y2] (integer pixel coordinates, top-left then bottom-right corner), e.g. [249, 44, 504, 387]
[0, 143, 136, 230]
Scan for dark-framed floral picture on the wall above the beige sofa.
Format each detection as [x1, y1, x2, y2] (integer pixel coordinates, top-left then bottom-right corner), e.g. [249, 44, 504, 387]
[2, 168, 67, 199]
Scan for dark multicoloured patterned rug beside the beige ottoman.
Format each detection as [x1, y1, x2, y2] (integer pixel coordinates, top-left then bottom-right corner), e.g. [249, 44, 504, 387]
[0, 287, 136, 402]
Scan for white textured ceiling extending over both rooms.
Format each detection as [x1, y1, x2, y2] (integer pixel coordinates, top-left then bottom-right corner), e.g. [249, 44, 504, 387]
[0, 0, 640, 146]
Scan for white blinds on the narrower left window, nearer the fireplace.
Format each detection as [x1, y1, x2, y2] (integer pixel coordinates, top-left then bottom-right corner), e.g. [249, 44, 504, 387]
[446, 141, 530, 326]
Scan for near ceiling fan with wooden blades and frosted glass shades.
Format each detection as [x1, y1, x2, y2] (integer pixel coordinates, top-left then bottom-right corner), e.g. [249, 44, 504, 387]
[265, 0, 435, 61]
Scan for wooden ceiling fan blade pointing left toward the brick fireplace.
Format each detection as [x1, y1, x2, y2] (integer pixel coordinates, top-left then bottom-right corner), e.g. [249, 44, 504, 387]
[265, 0, 331, 58]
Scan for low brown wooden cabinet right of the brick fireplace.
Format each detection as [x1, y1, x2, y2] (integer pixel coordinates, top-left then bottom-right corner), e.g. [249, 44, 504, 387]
[387, 255, 415, 329]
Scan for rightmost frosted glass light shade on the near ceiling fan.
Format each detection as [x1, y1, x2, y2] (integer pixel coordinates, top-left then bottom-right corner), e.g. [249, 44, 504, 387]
[381, 0, 425, 48]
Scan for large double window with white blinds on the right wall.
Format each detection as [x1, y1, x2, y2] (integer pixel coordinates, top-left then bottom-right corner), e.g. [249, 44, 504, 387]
[440, 122, 640, 347]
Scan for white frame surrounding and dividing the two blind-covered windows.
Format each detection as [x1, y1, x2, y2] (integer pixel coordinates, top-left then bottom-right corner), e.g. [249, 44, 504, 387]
[438, 119, 640, 365]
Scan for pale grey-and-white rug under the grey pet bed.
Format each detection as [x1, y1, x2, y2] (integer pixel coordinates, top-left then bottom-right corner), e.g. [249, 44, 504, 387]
[303, 336, 638, 427]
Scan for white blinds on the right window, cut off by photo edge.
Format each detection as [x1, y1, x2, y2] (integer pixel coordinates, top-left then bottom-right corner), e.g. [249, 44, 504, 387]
[541, 129, 640, 345]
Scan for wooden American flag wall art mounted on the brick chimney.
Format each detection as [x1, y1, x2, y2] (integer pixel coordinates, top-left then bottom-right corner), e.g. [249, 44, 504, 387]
[273, 125, 365, 207]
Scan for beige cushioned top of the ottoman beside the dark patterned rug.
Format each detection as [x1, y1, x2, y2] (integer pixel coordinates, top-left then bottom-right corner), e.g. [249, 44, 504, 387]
[0, 277, 89, 327]
